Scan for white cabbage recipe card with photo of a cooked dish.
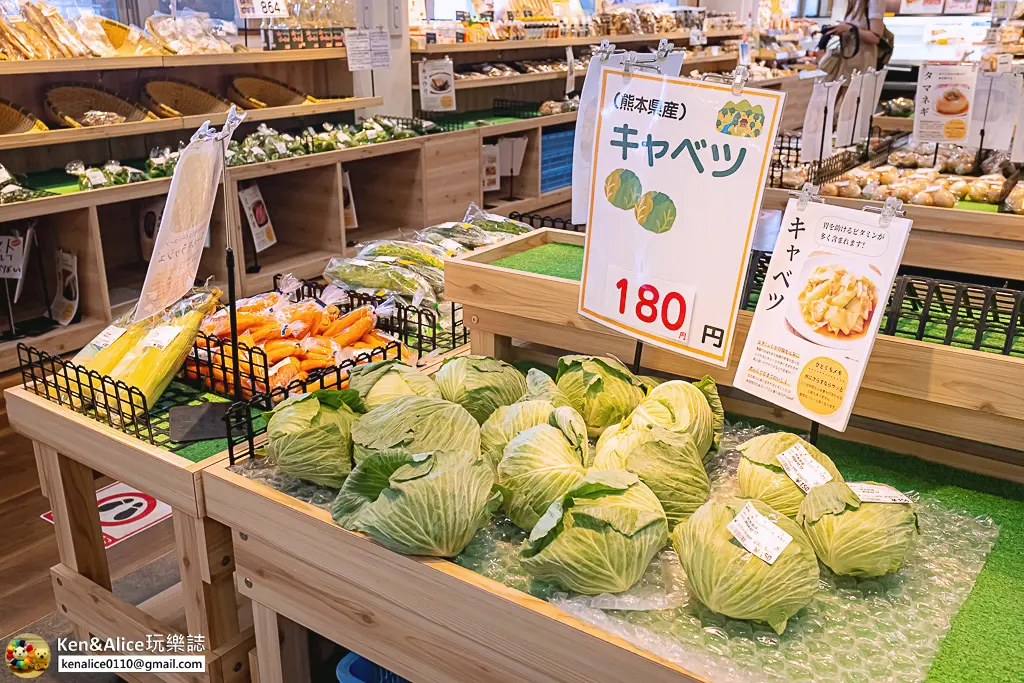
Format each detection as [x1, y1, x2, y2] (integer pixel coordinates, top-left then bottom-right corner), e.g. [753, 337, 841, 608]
[733, 200, 910, 431]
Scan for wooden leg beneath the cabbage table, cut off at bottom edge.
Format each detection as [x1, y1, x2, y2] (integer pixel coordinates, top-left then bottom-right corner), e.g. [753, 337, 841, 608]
[253, 602, 309, 683]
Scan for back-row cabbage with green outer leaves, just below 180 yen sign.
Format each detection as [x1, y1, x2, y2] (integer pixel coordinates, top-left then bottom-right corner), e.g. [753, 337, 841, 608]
[555, 355, 644, 438]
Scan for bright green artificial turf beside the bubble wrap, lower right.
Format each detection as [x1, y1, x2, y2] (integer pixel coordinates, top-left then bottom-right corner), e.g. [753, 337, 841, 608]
[728, 415, 1024, 683]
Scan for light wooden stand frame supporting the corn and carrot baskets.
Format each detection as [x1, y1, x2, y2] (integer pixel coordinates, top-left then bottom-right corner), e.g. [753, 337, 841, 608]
[5, 388, 254, 683]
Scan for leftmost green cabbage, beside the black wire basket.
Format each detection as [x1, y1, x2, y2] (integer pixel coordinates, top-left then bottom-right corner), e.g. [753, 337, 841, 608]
[265, 389, 362, 488]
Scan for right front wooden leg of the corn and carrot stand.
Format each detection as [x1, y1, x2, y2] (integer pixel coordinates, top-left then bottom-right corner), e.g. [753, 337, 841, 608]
[172, 510, 240, 651]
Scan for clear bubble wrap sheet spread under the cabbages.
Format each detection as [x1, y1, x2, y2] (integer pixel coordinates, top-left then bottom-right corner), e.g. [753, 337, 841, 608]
[233, 427, 998, 683]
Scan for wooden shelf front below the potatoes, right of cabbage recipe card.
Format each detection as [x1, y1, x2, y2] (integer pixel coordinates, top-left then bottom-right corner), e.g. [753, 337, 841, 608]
[763, 188, 1024, 280]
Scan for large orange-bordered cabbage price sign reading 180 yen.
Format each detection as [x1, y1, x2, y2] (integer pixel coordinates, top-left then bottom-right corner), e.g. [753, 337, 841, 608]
[580, 69, 785, 367]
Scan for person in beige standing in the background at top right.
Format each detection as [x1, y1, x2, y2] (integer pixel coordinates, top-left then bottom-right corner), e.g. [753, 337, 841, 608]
[818, 0, 892, 82]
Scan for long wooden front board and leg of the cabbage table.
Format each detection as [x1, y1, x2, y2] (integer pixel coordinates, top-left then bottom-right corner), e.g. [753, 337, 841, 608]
[203, 446, 699, 683]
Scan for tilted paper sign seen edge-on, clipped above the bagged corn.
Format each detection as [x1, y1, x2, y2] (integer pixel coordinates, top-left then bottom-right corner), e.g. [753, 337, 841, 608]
[134, 111, 245, 321]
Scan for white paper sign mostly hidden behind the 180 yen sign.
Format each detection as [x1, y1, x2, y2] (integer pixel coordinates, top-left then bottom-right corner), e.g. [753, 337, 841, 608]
[572, 45, 685, 223]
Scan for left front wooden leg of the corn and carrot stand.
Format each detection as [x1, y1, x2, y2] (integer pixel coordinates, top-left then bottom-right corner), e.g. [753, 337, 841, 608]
[35, 443, 111, 640]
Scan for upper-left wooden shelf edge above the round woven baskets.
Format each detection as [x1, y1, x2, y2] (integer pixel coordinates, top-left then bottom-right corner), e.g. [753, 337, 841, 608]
[0, 47, 348, 77]
